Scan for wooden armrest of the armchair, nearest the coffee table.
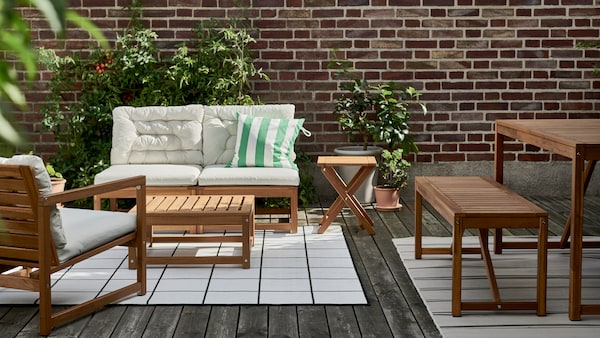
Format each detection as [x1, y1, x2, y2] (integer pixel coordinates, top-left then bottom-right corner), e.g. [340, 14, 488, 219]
[39, 176, 146, 206]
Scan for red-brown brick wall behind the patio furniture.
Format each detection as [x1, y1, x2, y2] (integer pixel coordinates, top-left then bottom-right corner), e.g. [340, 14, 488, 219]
[18, 0, 600, 163]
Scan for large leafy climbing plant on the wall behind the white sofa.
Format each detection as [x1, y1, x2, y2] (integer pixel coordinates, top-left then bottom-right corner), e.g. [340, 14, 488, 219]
[39, 1, 267, 193]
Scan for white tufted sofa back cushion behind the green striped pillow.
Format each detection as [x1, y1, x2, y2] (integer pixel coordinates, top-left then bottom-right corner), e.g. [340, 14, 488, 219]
[202, 104, 295, 166]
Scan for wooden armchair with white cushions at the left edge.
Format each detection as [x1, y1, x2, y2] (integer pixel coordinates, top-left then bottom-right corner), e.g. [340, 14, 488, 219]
[0, 155, 146, 335]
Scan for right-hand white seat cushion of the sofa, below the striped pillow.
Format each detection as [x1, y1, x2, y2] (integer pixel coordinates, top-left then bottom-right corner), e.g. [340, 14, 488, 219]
[198, 164, 300, 186]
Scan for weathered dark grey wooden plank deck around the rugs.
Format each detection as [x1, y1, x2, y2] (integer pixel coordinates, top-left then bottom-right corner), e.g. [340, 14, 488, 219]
[0, 192, 600, 337]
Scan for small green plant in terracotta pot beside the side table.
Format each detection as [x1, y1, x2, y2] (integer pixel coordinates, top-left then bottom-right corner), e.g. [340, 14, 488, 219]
[374, 148, 410, 211]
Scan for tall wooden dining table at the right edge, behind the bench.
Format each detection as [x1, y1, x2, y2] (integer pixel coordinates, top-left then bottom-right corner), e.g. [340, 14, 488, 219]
[495, 119, 600, 320]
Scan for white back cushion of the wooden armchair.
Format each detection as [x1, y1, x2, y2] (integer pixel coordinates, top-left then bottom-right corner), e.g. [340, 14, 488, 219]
[0, 155, 67, 249]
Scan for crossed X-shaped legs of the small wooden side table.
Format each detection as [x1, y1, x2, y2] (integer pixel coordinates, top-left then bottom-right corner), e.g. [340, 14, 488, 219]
[318, 166, 375, 235]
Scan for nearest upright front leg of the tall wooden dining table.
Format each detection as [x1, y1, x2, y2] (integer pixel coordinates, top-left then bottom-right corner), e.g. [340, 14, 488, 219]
[569, 151, 584, 320]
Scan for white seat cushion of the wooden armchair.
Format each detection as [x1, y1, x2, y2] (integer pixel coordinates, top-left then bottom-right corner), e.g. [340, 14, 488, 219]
[57, 208, 136, 262]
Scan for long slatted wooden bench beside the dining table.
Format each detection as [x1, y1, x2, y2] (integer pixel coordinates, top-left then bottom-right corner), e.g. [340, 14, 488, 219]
[415, 176, 548, 316]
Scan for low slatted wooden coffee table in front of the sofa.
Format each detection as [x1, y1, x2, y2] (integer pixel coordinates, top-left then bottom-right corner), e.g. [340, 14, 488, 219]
[130, 195, 254, 269]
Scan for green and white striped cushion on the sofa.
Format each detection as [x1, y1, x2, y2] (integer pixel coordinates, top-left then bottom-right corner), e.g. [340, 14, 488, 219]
[227, 113, 304, 170]
